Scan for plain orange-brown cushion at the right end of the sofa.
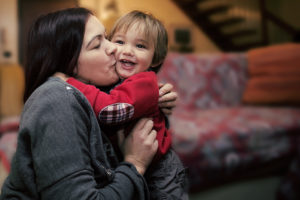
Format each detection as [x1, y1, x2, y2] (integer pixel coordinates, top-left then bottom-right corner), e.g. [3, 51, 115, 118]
[243, 43, 300, 105]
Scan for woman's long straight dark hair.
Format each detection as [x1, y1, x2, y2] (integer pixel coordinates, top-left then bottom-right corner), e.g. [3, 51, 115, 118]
[24, 8, 93, 102]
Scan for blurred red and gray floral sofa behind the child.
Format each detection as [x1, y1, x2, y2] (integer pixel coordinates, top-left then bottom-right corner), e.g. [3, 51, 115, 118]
[159, 44, 300, 199]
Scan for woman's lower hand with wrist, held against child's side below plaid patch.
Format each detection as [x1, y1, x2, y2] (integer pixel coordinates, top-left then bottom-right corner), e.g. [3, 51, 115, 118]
[118, 118, 158, 175]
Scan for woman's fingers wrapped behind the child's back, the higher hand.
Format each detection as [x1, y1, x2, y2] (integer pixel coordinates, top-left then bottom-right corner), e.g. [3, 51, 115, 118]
[158, 83, 178, 115]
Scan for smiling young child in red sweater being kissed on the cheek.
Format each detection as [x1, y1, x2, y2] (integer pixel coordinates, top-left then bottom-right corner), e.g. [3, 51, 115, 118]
[67, 11, 188, 199]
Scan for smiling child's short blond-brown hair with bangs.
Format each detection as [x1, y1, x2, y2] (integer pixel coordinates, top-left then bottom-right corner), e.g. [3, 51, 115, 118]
[108, 10, 168, 73]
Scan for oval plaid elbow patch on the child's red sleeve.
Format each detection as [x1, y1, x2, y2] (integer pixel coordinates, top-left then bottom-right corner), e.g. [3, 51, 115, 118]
[98, 103, 134, 124]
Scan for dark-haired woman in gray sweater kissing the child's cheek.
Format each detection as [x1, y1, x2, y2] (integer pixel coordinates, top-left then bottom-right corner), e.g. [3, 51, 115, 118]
[0, 8, 176, 199]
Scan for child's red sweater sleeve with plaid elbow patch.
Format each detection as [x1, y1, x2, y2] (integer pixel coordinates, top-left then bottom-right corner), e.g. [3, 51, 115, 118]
[67, 72, 159, 125]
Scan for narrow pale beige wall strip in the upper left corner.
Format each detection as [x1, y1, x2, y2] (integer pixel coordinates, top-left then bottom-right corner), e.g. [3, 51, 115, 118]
[0, 0, 18, 63]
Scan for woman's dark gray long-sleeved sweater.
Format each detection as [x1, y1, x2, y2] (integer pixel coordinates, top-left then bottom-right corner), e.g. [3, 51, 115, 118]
[0, 78, 149, 200]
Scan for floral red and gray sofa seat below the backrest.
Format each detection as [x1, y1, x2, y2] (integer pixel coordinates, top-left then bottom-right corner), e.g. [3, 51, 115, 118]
[170, 107, 300, 189]
